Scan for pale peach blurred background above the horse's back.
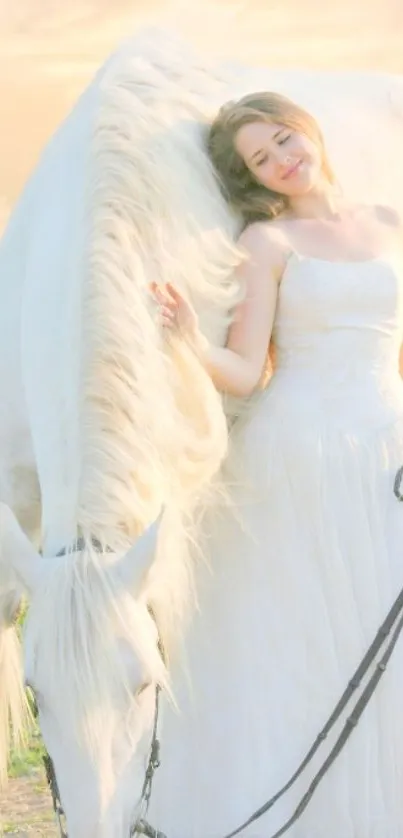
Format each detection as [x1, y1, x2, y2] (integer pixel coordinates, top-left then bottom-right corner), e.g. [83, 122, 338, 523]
[0, 0, 403, 225]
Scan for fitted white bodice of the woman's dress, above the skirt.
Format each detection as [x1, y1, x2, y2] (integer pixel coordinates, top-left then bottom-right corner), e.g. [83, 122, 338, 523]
[269, 249, 403, 425]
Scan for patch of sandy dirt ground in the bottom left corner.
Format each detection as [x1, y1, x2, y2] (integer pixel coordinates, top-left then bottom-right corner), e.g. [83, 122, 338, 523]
[0, 770, 58, 838]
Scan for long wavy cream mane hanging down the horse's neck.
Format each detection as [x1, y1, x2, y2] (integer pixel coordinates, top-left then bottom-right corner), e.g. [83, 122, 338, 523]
[78, 29, 245, 543]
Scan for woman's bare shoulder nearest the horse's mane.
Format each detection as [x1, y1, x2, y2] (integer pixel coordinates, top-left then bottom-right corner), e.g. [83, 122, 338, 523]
[238, 221, 289, 276]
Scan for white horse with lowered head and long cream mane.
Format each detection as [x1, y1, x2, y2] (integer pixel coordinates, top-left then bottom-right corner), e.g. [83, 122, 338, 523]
[0, 33, 403, 838]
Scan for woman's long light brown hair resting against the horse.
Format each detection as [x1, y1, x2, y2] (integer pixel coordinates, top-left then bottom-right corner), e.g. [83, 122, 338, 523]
[207, 92, 335, 223]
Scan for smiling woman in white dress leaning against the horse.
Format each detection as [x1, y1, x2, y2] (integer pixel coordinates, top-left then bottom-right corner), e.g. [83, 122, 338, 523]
[153, 93, 403, 838]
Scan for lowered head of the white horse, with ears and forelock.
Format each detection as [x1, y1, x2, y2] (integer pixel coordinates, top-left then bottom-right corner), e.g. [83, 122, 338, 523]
[0, 507, 166, 838]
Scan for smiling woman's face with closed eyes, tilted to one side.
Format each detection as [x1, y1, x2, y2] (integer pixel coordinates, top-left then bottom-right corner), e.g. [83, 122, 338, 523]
[235, 122, 323, 198]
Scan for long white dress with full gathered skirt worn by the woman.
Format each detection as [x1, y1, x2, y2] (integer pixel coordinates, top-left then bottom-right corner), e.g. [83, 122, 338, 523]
[150, 254, 403, 838]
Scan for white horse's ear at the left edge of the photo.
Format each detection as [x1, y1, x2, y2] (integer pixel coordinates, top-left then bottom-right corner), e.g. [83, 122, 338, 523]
[0, 503, 44, 593]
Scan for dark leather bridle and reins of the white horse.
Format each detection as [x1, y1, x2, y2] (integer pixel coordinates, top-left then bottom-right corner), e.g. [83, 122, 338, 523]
[29, 466, 403, 838]
